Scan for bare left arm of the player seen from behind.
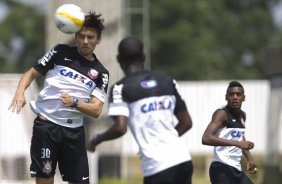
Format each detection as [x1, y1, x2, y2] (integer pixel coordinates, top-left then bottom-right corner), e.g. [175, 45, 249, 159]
[87, 116, 128, 152]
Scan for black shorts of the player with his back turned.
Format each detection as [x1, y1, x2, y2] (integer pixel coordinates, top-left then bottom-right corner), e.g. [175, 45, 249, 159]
[144, 161, 193, 184]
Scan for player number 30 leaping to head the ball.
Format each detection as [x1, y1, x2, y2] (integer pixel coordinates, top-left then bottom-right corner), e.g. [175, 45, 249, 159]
[9, 12, 109, 184]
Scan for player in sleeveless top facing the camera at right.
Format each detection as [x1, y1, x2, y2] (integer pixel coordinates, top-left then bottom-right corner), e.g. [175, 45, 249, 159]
[202, 81, 257, 184]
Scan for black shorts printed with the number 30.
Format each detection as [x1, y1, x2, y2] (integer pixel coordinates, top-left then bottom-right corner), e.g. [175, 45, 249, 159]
[30, 117, 89, 183]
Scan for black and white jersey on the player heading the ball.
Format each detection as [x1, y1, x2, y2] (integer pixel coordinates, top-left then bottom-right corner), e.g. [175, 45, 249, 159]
[30, 45, 109, 128]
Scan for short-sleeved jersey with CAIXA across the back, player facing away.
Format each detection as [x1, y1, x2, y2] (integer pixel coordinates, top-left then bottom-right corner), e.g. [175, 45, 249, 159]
[108, 71, 191, 176]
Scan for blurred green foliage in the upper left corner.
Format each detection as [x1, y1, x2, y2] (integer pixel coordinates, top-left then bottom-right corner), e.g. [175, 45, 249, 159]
[0, 0, 45, 73]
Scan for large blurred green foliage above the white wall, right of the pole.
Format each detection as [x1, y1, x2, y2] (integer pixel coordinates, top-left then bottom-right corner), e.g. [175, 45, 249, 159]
[150, 0, 274, 80]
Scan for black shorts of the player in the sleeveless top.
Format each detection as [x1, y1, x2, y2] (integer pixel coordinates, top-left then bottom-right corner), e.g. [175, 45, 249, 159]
[209, 162, 253, 184]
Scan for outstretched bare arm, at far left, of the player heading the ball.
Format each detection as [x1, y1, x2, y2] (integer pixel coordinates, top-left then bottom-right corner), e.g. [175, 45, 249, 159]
[8, 68, 40, 113]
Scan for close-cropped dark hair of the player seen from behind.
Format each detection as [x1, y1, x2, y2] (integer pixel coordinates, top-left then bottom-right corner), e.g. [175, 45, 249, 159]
[118, 37, 145, 62]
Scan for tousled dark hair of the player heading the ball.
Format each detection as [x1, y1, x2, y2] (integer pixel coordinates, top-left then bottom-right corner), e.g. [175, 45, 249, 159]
[83, 12, 105, 38]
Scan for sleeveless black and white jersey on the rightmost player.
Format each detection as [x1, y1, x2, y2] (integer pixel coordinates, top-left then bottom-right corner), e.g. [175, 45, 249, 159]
[213, 107, 245, 171]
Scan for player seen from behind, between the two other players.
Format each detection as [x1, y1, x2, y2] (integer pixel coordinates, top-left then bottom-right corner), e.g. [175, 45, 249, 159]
[88, 37, 193, 184]
